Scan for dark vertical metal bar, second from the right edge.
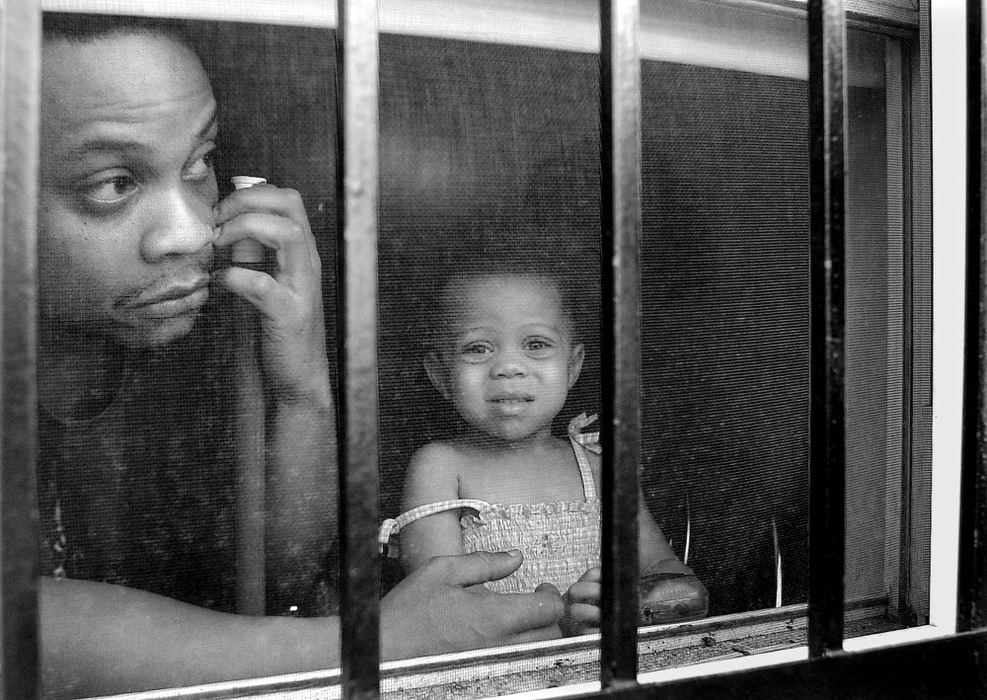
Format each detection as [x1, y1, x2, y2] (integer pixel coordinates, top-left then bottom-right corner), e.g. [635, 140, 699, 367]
[808, 0, 846, 657]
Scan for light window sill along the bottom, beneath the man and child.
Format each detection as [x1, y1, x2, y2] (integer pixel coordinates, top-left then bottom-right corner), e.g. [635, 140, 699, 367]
[96, 598, 950, 700]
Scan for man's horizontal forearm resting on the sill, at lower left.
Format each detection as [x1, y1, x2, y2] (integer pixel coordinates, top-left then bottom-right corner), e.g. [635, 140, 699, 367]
[39, 578, 339, 697]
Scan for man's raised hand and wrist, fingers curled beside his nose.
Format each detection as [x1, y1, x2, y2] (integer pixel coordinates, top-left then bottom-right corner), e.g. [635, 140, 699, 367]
[214, 185, 331, 406]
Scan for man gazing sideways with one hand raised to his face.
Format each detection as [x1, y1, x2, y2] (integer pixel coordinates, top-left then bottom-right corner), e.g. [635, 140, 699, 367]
[39, 17, 563, 695]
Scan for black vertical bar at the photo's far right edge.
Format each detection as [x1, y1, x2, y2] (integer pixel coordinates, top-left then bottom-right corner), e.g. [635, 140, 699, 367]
[956, 0, 987, 631]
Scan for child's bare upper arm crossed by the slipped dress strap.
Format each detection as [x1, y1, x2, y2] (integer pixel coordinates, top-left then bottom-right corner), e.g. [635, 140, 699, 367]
[400, 443, 463, 574]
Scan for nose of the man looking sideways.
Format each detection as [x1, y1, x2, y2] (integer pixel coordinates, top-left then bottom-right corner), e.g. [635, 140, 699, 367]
[141, 186, 216, 262]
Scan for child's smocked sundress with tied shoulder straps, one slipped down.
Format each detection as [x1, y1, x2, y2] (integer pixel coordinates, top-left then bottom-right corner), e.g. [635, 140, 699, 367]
[380, 413, 601, 593]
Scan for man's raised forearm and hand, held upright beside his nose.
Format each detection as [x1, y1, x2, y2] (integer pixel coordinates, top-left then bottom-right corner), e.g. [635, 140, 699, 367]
[215, 185, 337, 611]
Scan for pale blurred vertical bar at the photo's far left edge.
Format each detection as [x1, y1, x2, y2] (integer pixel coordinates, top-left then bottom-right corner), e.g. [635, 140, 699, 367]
[0, 0, 41, 698]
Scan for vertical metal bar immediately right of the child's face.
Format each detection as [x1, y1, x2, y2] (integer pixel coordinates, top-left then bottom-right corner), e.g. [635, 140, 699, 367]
[600, 0, 641, 688]
